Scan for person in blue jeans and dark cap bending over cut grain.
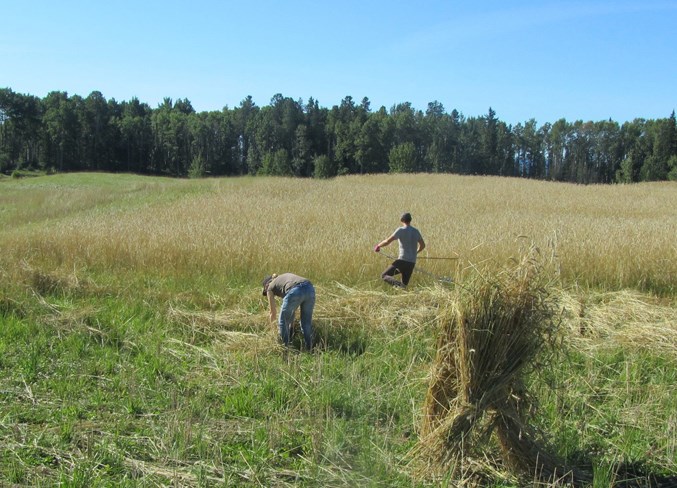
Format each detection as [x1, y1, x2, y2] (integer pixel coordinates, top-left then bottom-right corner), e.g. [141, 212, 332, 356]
[263, 273, 315, 351]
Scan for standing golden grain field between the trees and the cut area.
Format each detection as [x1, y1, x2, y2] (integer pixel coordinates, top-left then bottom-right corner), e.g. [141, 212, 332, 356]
[0, 175, 677, 295]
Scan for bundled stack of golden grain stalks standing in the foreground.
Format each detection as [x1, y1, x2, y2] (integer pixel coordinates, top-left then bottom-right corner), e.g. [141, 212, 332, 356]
[416, 250, 583, 486]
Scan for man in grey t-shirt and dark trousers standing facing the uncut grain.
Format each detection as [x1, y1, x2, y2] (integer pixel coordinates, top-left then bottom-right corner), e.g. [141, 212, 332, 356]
[374, 212, 425, 288]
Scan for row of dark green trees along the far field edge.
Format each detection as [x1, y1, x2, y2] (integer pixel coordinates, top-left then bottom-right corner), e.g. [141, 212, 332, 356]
[0, 88, 677, 184]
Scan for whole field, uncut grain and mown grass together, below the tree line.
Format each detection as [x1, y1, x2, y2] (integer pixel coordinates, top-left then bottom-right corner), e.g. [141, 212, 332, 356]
[0, 174, 677, 487]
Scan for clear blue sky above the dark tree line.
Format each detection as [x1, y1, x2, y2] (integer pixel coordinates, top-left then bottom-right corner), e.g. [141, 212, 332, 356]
[0, 0, 677, 124]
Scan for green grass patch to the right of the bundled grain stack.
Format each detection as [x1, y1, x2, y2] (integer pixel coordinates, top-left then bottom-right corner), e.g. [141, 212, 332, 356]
[532, 347, 677, 475]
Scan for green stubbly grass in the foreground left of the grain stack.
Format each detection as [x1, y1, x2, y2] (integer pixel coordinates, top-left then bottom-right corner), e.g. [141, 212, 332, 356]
[0, 284, 430, 486]
